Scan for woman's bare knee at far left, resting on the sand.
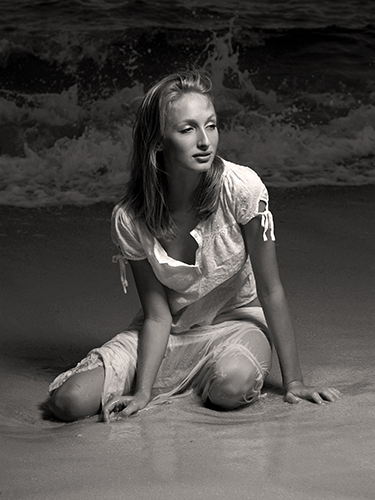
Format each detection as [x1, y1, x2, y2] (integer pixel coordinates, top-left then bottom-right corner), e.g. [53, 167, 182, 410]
[49, 368, 104, 422]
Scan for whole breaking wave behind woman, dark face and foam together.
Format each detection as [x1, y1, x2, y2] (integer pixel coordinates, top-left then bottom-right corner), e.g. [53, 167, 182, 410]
[0, 24, 375, 207]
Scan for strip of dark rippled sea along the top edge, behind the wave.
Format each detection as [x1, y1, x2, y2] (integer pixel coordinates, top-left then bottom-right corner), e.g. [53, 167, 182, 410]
[0, 0, 375, 36]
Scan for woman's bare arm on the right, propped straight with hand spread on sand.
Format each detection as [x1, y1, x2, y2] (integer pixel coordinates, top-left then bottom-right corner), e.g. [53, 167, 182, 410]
[241, 215, 340, 404]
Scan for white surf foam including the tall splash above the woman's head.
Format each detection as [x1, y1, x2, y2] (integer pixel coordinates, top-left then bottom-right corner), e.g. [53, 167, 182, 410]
[0, 30, 375, 207]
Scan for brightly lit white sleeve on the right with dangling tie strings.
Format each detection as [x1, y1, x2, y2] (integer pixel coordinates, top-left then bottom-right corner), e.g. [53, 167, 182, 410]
[224, 162, 275, 240]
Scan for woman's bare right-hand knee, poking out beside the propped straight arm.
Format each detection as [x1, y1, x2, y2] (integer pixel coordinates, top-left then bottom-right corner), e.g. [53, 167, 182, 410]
[208, 356, 262, 409]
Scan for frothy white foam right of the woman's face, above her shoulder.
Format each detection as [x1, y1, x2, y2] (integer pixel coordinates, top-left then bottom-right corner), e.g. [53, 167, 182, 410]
[220, 106, 375, 187]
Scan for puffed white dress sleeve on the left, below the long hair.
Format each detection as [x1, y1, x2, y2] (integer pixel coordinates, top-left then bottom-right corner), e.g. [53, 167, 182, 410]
[112, 205, 146, 260]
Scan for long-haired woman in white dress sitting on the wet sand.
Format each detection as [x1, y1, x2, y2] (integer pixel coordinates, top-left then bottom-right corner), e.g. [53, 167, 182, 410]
[50, 71, 340, 421]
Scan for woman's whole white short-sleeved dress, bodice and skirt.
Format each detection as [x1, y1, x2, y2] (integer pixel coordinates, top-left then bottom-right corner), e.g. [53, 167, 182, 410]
[50, 160, 275, 410]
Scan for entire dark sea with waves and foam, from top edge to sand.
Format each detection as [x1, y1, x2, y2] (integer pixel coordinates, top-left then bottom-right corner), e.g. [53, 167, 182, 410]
[0, 0, 375, 207]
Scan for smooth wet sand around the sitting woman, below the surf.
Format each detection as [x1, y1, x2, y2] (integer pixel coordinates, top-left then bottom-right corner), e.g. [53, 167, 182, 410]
[0, 186, 375, 500]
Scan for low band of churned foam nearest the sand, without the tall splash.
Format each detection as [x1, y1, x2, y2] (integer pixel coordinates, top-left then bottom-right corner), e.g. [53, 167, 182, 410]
[0, 87, 375, 207]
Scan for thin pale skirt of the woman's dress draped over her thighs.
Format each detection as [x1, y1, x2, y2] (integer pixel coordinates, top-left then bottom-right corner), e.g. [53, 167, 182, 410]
[49, 307, 272, 409]
